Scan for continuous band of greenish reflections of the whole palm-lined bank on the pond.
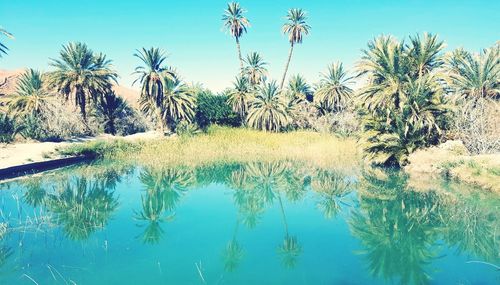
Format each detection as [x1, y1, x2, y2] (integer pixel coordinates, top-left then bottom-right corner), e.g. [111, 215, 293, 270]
[0, 161, 500, 284]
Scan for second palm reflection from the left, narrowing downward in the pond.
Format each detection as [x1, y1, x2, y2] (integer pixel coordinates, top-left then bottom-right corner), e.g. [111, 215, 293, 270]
[136, 168, 195, 243]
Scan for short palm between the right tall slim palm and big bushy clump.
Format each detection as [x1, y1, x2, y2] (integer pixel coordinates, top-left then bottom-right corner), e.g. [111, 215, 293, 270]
[314, 62, 354, 112]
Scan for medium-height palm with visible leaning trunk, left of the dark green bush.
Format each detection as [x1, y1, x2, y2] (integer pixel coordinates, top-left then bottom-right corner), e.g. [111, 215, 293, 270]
[133, 47, 175, 132]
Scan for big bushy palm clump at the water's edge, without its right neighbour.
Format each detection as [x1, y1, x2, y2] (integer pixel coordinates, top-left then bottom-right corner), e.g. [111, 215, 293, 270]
[359, 34, 449, 166]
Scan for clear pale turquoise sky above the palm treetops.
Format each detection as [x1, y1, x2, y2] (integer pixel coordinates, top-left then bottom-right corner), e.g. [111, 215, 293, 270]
[0, 0, 500, 91]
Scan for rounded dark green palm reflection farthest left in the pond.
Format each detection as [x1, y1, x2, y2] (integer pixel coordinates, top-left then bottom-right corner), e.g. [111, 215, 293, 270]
[48, 178, 118, 240]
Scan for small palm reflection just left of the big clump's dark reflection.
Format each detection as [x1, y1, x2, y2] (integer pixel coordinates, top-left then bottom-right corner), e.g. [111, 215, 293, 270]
[311, 170, 352, 219]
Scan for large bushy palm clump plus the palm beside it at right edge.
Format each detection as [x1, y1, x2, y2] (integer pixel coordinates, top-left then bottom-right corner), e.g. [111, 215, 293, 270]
[357, 34, 500, 166]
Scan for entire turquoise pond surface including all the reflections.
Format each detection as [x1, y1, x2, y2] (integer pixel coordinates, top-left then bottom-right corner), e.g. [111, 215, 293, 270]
[0, 162, 500, 285]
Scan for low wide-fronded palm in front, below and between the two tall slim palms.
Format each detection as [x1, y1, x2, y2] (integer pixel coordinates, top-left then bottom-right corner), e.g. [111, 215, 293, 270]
[247, 81, 289, 132]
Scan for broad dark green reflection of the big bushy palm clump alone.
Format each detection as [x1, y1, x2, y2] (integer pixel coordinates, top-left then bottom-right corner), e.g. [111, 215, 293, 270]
[349, 169, 440, 284]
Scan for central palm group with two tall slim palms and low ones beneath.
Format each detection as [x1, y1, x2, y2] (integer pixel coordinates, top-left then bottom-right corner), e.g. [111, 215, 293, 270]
[222, 2, 353, 132]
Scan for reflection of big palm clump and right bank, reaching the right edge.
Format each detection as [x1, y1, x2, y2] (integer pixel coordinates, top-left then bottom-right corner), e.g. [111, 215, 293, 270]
[349, 171, 498, 284]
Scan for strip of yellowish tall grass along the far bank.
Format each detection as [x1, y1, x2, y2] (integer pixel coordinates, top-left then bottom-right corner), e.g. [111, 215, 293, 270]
[60, 126, 361, 168]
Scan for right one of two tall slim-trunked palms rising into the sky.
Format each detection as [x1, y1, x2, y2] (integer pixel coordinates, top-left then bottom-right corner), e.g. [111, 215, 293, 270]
[280, 9, 311, 90]
